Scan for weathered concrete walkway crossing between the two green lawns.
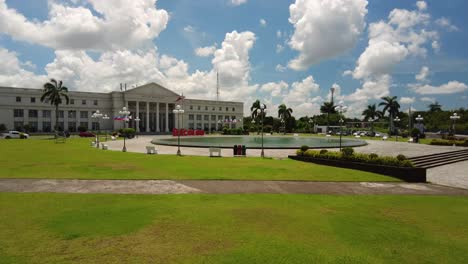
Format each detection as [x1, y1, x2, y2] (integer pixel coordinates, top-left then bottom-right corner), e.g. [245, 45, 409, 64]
[0, 179, 468, 196]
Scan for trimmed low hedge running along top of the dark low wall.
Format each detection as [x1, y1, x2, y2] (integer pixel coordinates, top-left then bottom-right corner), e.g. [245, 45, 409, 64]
[296, 150, 414, 168]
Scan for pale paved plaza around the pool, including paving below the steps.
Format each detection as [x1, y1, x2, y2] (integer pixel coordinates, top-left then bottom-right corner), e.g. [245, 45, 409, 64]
[106, 135, 468, 189]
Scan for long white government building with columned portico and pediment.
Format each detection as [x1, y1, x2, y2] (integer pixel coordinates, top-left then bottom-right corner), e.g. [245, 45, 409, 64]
[0, 83, 244, 133]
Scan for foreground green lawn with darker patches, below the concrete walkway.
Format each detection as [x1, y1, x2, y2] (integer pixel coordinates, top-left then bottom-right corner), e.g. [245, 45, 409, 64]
[0, 193, 468, 264]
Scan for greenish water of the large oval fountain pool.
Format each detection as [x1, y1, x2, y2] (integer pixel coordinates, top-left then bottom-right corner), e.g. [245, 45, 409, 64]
[151, 136, 367, 149]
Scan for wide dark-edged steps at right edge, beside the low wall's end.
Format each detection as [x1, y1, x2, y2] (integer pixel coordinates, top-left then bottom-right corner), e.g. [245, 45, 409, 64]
[409, 149, 468, 169]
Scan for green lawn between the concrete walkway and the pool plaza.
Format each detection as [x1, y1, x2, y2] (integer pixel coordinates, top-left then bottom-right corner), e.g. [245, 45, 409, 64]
[0, 138, 398, 181]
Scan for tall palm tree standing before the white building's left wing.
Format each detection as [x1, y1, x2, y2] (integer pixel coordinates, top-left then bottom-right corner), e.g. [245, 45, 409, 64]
[41, 79, 70, 136]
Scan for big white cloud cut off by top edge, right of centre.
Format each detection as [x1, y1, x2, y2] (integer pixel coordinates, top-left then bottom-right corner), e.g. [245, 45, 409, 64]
[289, 0, 367, 70]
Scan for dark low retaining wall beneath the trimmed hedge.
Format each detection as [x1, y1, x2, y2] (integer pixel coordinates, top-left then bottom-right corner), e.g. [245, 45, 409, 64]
[288, 155, 426, 182]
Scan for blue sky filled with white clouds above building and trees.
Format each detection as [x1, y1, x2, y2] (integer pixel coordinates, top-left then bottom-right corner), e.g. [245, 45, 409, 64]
[0, 0, 468, 116]
